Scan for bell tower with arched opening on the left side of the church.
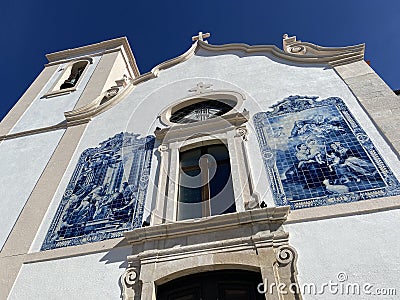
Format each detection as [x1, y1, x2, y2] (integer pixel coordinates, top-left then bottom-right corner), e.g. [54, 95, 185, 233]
[0, 37, 140, 298]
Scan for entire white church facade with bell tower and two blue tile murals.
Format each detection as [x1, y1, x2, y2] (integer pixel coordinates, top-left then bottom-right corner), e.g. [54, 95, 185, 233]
[0, 33, 400, 300]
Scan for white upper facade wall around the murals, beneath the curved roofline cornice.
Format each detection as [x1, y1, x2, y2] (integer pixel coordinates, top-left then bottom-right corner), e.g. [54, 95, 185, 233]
[33, 50, 400, 240]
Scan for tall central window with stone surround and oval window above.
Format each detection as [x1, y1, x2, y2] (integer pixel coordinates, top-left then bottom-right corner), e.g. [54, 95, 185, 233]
[151, 90, 258, 224]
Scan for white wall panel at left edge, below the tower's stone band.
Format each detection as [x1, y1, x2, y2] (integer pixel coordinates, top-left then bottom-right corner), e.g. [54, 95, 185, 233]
[0, 130, 64, 249]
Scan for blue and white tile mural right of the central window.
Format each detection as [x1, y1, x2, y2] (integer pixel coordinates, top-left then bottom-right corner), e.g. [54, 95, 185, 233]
[254, 96, 400, 209]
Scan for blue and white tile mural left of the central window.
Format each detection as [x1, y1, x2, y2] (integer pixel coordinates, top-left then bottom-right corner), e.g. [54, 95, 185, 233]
[42, 133, 154, 250]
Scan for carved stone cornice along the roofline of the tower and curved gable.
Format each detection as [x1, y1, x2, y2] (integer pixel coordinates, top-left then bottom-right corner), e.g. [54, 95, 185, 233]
[26, 36, 365, 132]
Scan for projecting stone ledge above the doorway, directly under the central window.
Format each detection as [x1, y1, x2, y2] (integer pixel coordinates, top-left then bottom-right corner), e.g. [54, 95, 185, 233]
[124, 206, 289, 245]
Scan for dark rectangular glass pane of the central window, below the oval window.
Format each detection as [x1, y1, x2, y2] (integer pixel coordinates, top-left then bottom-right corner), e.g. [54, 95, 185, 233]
[177, 144, 236, 220]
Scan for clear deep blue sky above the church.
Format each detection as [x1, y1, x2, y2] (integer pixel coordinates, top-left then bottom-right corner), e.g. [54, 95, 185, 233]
[0, 0, 400, 119]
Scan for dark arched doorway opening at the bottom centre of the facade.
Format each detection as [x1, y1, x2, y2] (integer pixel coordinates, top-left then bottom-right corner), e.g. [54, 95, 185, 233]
[157, 270, 265, 300]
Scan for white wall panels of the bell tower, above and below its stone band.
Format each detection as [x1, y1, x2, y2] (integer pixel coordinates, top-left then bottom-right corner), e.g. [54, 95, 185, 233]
[0, 57, 100, 249]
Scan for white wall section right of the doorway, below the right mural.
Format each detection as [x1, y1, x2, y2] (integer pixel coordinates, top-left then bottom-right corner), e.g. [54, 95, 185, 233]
[284, 210, 400, 299]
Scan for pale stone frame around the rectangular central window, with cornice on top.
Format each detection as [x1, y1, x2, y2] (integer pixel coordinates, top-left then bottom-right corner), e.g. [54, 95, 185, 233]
[151, 111, 258, 225]
